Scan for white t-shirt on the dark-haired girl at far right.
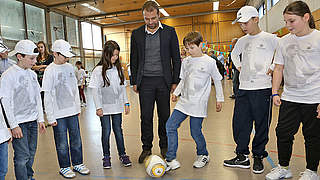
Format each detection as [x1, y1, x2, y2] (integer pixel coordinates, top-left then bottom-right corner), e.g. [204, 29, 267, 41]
[275, 30, 320, 104]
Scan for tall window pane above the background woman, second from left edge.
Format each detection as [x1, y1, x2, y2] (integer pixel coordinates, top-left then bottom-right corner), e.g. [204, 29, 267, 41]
[26, 4, 46, 42]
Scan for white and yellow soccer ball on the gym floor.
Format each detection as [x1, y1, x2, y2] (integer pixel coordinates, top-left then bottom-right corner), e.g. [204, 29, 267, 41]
[145, 155, 167, 178]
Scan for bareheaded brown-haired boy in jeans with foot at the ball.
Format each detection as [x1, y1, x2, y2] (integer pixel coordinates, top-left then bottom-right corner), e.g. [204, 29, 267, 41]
[166, 32, 224, 170]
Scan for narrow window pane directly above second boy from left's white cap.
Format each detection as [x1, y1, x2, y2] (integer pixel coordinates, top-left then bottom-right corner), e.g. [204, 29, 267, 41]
[50, 12, 65, 42]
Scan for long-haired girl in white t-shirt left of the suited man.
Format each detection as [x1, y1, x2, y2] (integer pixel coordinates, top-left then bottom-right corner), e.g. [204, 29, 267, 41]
[89, 41, 131, 169]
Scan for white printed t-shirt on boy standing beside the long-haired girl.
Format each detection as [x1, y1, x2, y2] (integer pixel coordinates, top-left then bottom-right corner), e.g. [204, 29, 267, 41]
[42, 63, 81, 123]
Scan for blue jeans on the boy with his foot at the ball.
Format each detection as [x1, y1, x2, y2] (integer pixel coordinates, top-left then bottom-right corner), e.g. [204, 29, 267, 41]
[166, 109, 208, 161]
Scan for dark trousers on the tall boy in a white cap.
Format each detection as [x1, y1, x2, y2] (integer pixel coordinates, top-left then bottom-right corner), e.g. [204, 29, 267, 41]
[232, 88, 272, 157]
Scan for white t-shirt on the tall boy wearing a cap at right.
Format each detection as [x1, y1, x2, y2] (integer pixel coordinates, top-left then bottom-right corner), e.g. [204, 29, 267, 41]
[231, 31, 279, 90]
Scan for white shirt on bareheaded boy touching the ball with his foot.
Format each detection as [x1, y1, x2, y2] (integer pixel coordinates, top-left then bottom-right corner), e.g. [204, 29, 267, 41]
[173, 55, 224, 117]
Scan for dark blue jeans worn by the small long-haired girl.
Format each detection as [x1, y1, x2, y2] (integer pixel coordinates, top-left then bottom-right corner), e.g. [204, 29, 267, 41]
[100, 113, 126, 157]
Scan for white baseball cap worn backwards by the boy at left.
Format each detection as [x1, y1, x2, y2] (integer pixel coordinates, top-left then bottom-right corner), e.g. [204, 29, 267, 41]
[8, 39, 39, 56]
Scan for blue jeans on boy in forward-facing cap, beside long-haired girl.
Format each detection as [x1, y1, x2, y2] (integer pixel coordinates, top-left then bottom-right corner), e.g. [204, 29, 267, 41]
[53, 115, 83, 168]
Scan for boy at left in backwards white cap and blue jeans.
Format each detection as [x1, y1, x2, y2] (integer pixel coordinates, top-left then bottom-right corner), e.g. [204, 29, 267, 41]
[1, 40, 45, 180]
